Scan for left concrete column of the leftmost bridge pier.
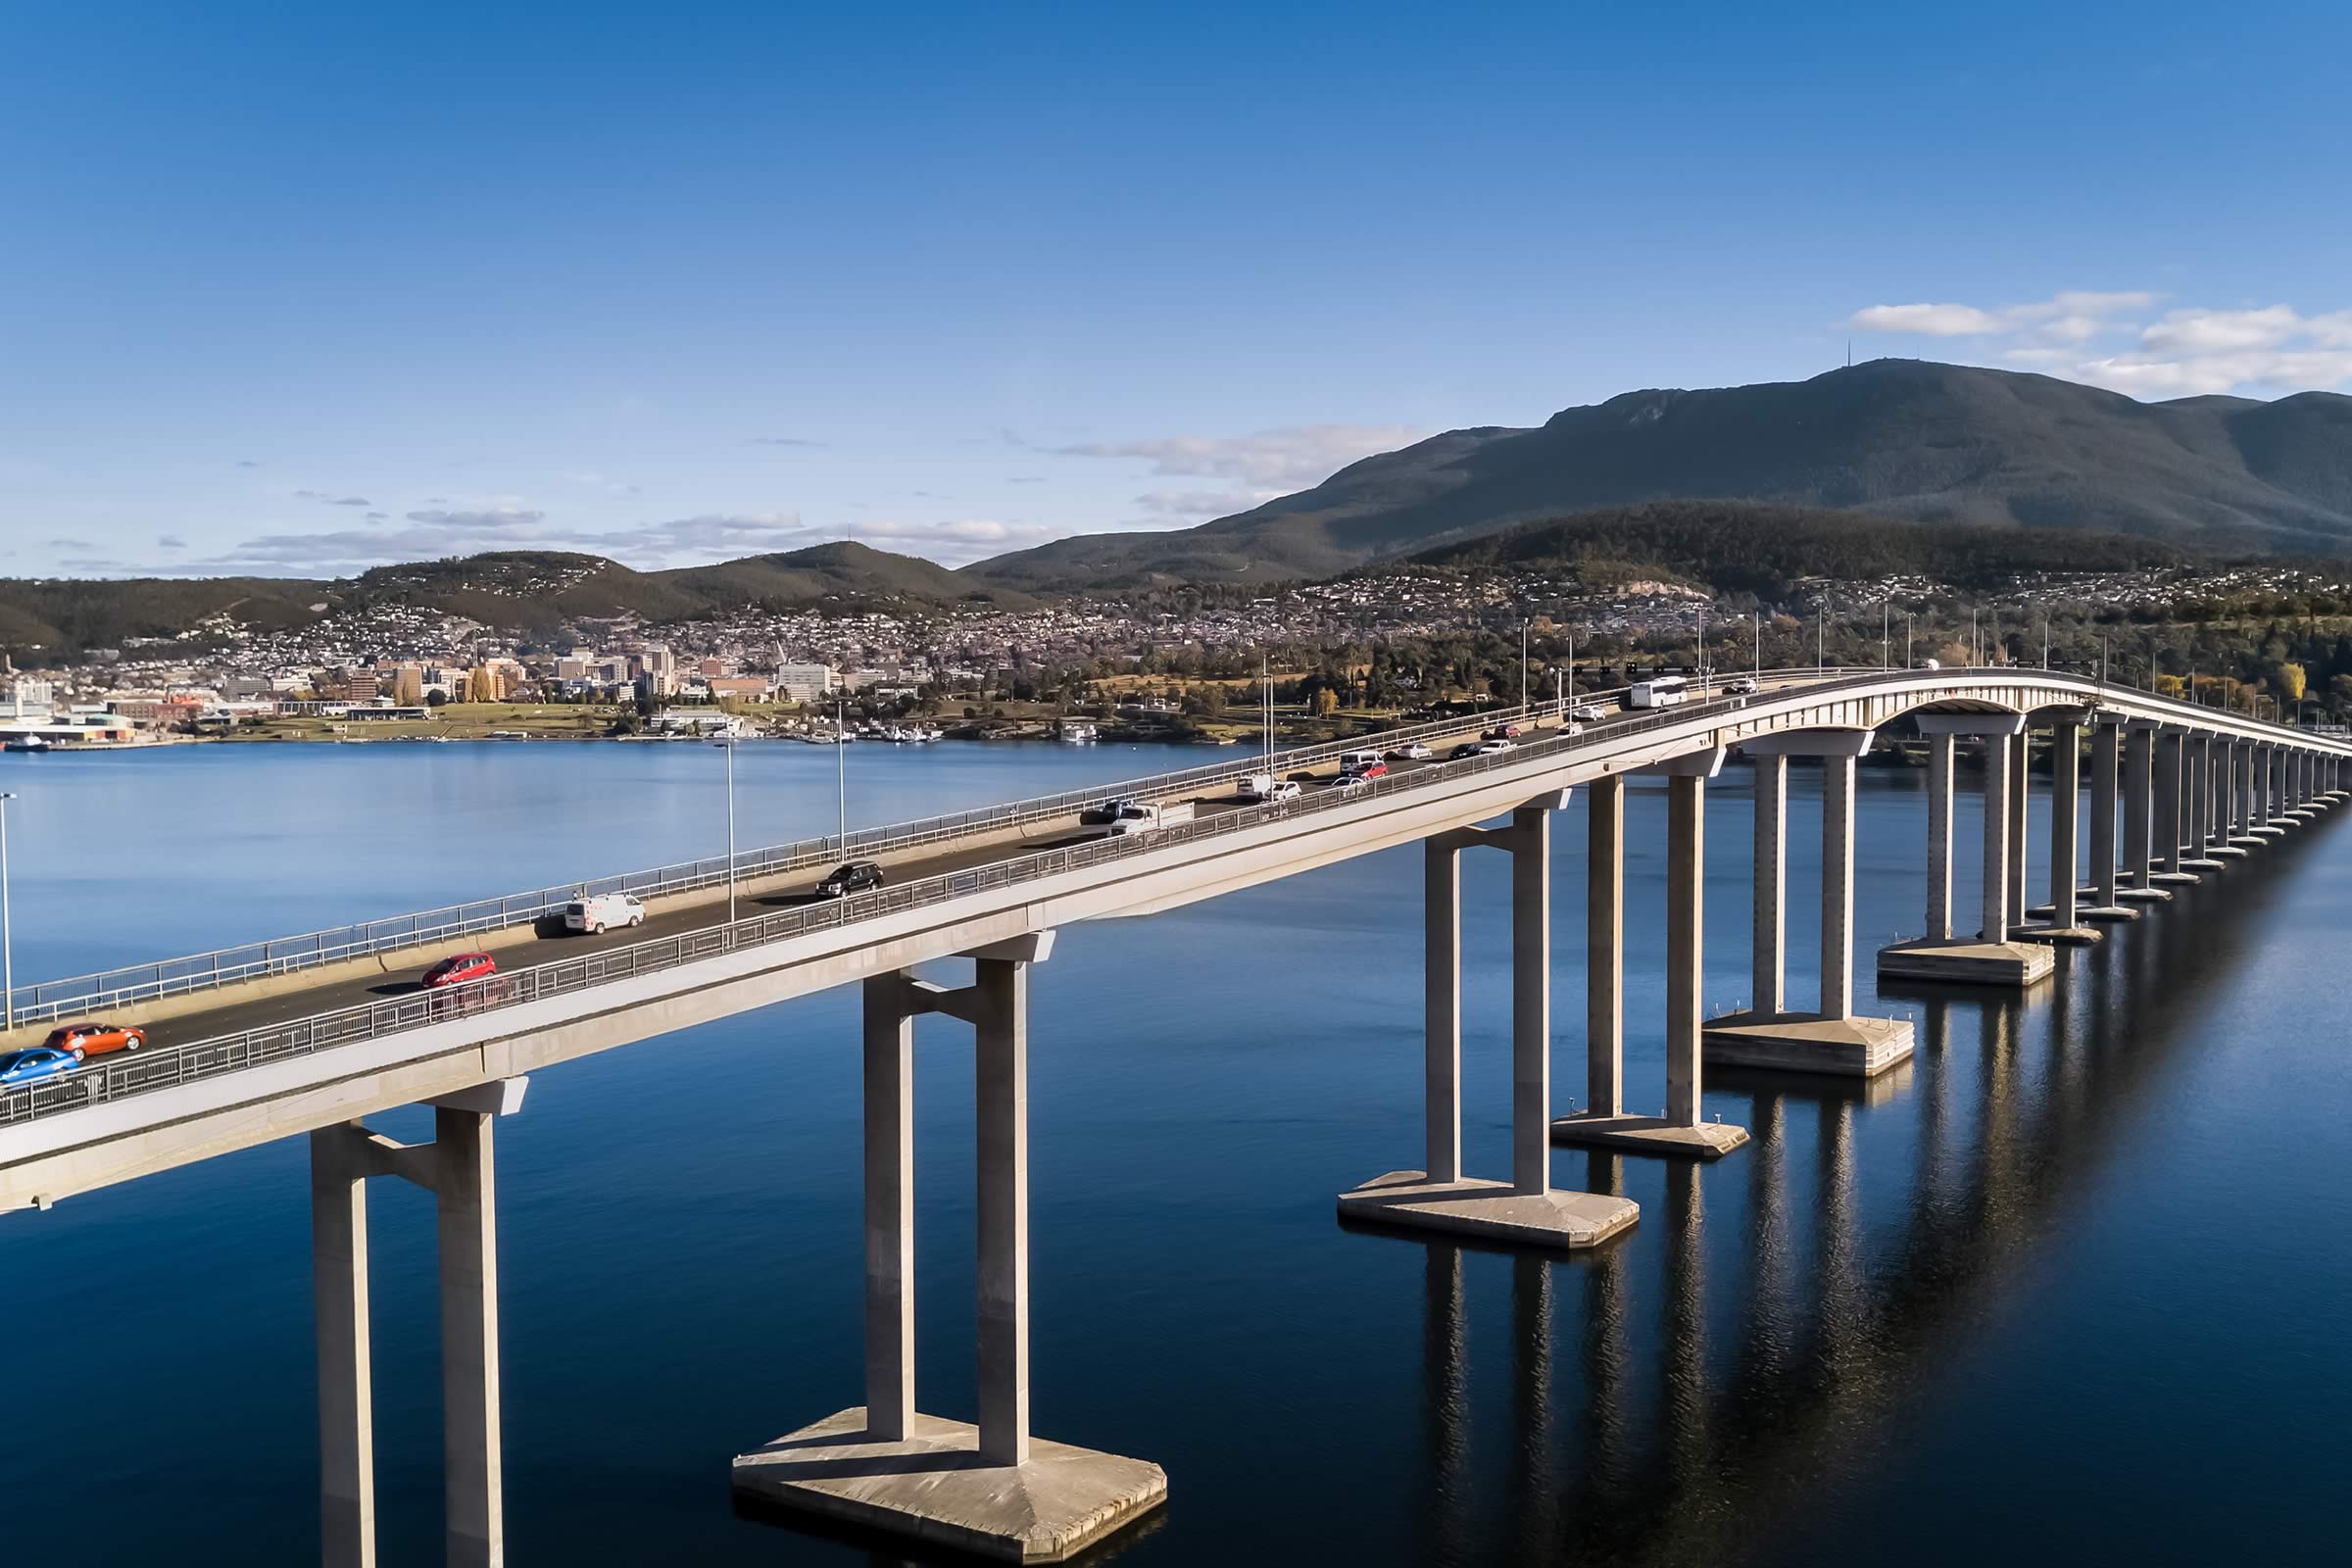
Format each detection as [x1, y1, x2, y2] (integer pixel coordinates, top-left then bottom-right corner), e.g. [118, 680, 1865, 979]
[311, 1126, 376, 1568]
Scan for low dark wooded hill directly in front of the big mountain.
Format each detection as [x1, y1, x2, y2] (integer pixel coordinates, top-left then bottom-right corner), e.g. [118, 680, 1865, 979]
[1350, 501, 2187, 602]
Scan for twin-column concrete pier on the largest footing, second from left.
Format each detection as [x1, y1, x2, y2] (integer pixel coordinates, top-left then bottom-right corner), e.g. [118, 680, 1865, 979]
[731, 931, 1166, 1561]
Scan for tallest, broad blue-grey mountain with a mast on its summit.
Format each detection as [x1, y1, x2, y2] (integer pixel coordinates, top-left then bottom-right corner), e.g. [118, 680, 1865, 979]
[964, 360, 2352, 588]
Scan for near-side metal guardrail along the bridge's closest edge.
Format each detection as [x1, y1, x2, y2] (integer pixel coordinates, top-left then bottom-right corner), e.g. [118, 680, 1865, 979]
[0, 667, 2307, 1126]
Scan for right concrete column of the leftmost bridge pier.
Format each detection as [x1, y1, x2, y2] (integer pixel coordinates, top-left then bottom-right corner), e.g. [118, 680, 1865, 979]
[433, 1104, 506, 1568]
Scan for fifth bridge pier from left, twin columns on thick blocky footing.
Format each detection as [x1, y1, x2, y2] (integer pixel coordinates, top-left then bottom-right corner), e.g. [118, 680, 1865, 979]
[1703, 729, 1912, 1079]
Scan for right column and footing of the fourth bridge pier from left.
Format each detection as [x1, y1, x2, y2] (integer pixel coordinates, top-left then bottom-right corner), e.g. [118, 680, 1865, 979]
[1552, 748, 1747, 1159]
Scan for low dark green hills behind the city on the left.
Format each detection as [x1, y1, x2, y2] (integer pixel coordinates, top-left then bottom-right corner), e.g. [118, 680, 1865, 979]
[0, 543, 1037, 662]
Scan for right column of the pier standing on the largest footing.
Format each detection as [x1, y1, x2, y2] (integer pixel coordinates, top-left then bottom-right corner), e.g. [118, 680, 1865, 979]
[971, 959, 1030, 1464]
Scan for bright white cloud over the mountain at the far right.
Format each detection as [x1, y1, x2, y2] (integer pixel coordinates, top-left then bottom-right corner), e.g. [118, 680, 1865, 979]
[1848, 291, 2352, 397]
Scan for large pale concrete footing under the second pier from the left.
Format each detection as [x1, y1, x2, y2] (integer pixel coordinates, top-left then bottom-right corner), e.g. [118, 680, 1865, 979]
[734, 1405, 1169, 1563]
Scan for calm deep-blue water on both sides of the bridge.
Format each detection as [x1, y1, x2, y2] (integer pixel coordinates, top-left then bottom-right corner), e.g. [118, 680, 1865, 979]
[0, 745, 2352, 1566]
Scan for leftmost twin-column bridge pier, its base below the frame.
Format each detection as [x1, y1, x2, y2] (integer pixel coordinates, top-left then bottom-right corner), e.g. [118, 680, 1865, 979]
[311, 1079, 529, 1568]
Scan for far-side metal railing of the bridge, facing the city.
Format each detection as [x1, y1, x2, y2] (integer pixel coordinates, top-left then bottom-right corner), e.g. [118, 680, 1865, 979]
[14, 689, 1731, 1022]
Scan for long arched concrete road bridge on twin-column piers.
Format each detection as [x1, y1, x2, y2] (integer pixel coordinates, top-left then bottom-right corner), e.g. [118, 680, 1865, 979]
[0, 667, 2352, 1563]
